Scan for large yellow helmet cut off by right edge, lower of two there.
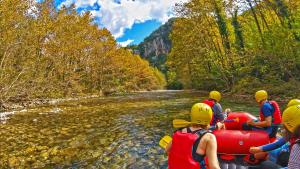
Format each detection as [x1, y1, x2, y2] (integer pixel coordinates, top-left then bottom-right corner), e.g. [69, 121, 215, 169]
[282, 105, 300, 133]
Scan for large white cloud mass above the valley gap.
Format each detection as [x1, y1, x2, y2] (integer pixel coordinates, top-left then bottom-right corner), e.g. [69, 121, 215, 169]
[61, 0, 188, 38]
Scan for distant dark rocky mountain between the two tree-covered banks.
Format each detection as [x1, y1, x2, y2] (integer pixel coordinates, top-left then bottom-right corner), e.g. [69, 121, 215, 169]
[129, 18, 175, 73]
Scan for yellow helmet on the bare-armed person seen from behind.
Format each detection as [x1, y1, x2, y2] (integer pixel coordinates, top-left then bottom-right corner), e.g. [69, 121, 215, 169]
[191, 103, 213, 125]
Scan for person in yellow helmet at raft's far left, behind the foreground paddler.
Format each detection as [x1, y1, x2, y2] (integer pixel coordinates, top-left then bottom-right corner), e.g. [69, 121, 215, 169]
[203, 91, 225, 129]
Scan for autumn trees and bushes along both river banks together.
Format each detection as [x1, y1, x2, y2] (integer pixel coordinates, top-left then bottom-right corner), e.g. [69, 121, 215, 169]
[0, 0, 300, 110]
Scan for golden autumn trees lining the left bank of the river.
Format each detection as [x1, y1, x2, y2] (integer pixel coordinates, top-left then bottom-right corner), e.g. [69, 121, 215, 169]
[0, 0, 165, 103]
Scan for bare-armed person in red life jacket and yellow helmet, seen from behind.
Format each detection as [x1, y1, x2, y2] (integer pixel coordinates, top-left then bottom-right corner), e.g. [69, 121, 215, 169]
[166, 103, 220, 169]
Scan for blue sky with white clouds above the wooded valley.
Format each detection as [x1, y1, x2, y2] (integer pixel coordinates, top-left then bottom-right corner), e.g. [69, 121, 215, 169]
[55, 0, 187, 46]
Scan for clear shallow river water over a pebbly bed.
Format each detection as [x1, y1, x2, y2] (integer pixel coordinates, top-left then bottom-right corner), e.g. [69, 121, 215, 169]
[0, 91, 258, 169]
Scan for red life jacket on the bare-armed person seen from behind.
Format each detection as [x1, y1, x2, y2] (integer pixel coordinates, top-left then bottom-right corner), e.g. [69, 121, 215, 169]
[168, 130, 208, 169]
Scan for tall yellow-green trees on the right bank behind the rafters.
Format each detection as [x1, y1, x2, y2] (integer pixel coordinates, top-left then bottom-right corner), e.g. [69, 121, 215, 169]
[168, 0, 300, 95]
